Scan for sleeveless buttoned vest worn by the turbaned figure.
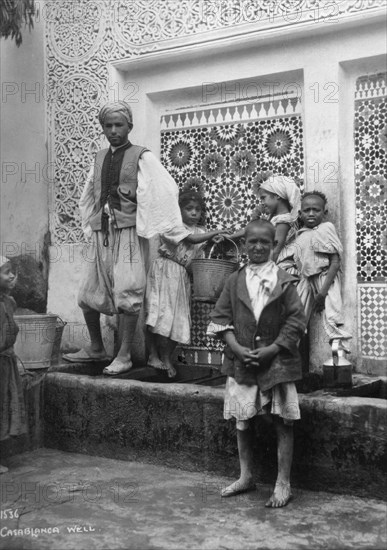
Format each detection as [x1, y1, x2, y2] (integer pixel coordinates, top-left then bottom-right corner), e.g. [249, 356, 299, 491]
[90, 143, 148, 231]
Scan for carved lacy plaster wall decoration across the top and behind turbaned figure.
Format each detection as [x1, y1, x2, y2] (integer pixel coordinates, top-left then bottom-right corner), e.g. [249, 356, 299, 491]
[43, 0, 384, 243]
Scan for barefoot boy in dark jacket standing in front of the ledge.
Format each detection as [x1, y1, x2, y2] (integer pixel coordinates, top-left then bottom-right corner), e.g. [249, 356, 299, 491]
[208, 220, 305, 508]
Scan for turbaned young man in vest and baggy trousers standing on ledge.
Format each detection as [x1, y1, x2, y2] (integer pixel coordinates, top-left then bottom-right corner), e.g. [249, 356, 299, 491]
[64, 101, 182, 375]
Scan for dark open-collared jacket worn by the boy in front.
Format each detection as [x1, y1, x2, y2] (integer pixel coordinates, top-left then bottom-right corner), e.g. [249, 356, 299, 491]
[211, 267, 306, 391]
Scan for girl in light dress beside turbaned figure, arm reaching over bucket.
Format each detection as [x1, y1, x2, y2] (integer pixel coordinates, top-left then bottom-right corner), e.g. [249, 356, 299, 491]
[145, 191, 229, 377]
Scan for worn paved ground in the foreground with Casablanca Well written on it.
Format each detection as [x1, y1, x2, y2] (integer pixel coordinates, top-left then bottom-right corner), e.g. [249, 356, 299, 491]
[0, 449, 387, 550]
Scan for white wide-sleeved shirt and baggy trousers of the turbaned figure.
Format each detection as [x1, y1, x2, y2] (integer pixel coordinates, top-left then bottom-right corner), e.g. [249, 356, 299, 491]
[78, 151, 182, 315]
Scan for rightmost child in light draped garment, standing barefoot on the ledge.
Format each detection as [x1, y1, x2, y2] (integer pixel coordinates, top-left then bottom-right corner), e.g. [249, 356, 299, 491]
[293, 191, 351, 340]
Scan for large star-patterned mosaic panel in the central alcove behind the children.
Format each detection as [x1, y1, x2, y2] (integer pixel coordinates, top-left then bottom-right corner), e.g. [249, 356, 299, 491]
[161, 105, 304, 363]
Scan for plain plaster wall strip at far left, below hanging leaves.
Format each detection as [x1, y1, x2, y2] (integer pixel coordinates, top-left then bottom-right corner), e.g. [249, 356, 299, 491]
[0, 21, 50, 260]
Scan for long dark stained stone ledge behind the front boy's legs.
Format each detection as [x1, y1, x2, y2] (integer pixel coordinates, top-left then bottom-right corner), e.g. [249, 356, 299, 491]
[44, 372, 387, 498]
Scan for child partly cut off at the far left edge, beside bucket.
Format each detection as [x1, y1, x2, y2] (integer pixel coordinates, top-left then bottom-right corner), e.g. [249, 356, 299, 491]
[0, 256, 27, 474]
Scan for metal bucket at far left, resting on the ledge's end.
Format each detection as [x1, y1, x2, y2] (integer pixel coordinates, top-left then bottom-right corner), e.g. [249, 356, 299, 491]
[14, 314, 57, 369]
